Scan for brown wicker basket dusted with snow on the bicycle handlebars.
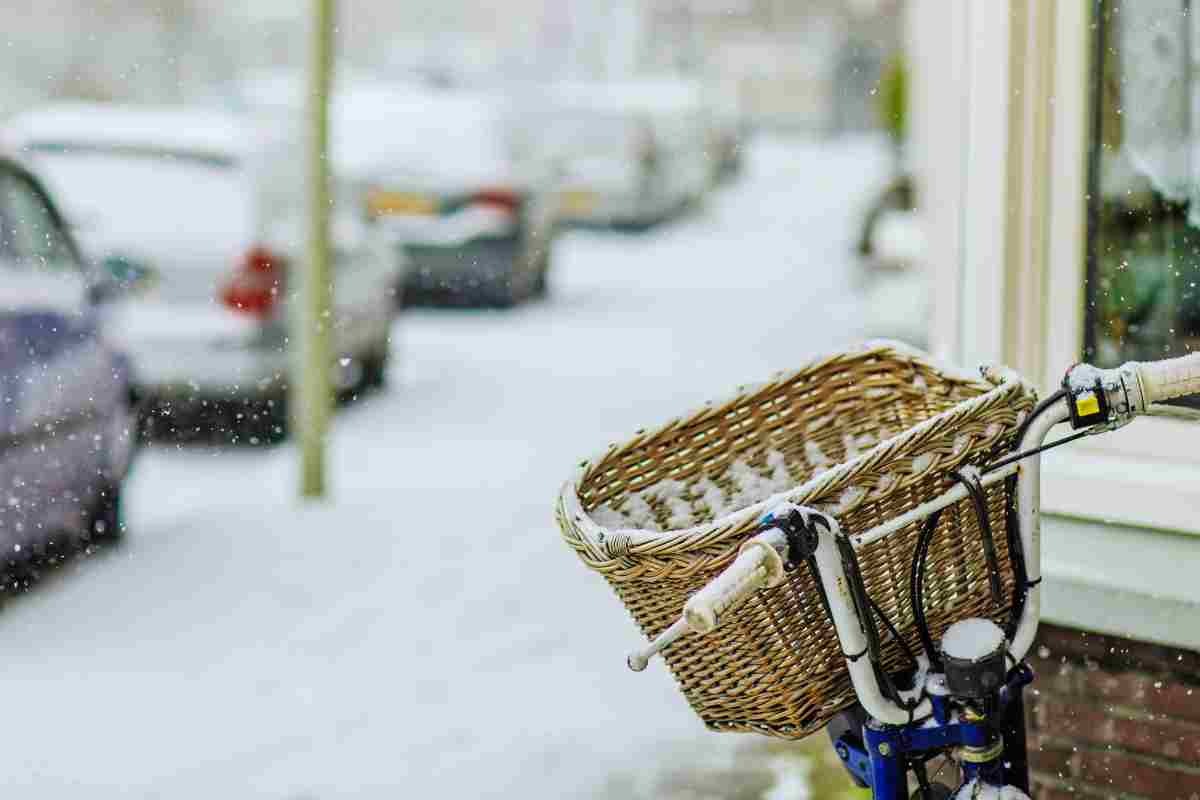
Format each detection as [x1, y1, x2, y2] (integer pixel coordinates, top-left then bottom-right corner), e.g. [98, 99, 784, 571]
[557, 343, 1036, 739]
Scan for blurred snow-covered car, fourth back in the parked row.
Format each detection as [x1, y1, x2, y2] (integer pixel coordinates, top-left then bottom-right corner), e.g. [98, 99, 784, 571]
[542, 80, 714, 228]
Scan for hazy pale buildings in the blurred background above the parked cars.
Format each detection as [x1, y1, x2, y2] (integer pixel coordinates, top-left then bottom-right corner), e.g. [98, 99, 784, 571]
[0, 0, 902, 131]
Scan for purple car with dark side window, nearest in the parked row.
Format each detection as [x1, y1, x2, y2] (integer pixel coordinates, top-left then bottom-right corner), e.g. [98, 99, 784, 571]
[0, 158, 137, 570]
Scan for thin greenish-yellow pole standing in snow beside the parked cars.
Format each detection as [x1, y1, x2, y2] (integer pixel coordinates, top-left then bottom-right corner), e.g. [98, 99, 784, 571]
[293, 0, 335, 498]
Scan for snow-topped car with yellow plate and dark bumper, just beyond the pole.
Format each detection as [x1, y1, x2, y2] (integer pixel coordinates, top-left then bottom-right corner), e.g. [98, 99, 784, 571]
[222, 71, 558, 307]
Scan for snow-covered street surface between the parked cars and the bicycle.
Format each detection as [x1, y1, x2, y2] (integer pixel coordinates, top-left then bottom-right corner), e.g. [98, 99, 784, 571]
[0, 138, 888, 800]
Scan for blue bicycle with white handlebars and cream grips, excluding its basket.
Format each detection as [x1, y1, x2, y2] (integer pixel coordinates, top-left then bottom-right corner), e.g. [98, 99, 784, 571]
[559, 345, 1200, 800]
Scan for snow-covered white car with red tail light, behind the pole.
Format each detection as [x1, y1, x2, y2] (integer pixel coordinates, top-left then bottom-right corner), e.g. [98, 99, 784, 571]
[2, 104, 400, 441]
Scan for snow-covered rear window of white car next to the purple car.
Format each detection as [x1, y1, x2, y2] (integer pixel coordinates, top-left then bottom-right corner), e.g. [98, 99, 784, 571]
[28, 143, 250, 270]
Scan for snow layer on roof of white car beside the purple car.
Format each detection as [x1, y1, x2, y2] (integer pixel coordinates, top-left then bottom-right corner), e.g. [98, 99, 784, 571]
[4, 103, 254, 158]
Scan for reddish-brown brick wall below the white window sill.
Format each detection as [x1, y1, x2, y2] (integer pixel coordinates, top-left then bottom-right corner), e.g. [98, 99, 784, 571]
[1026, 620, 1200, 800]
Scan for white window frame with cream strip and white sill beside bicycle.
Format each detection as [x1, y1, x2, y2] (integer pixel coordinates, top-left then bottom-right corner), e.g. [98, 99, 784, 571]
[908, 0, 1200, 649]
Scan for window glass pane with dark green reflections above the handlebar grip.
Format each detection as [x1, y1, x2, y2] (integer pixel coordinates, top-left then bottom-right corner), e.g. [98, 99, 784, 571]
[1085, 0, 1200, 366]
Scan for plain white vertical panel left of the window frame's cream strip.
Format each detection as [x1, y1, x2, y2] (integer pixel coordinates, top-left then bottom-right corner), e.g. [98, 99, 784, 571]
[907, 0, 1009, 363]
